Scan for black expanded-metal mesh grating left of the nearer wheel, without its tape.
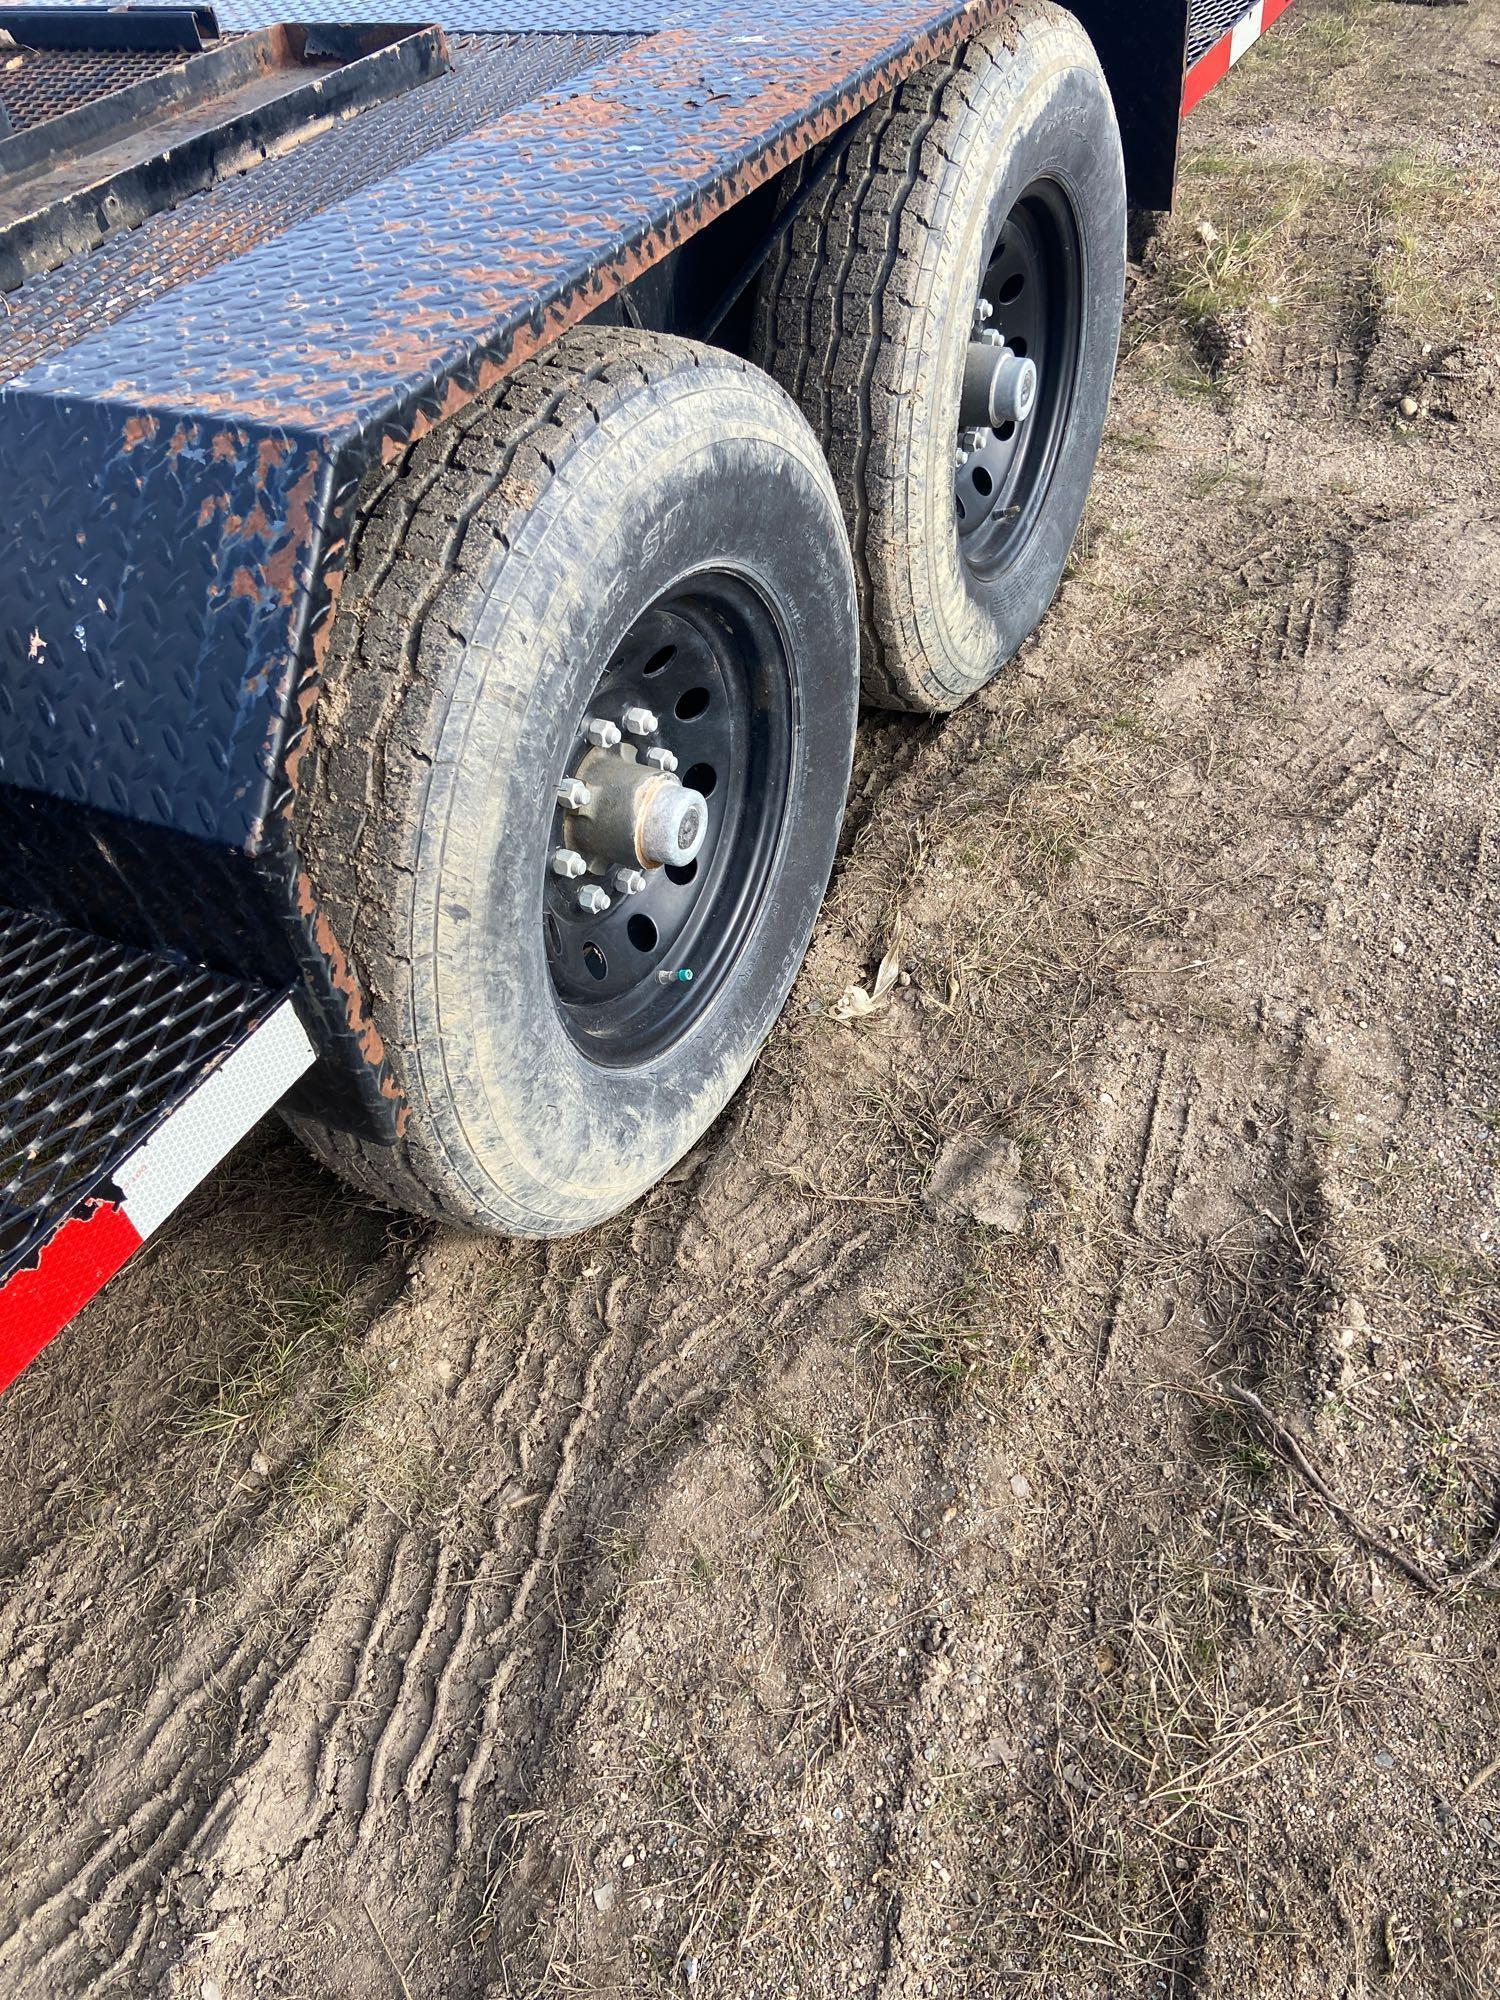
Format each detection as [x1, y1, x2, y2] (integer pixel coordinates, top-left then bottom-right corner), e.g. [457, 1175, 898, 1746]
[0, 910, 280, 1280]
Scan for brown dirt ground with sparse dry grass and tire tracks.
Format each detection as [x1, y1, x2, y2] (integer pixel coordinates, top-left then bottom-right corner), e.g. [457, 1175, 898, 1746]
[0, 0, 1500, 2000]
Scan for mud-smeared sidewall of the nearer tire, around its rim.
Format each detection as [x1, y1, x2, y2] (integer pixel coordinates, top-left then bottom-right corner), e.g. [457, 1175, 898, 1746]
[414, 368, 858, 1234]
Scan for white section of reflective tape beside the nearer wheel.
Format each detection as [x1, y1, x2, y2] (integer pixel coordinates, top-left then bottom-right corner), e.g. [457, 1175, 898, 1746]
[114, 1000, 312, 1238]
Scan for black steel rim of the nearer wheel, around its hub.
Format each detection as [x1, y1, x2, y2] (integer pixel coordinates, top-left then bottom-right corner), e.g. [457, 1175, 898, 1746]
[542, 570, 794, 1066]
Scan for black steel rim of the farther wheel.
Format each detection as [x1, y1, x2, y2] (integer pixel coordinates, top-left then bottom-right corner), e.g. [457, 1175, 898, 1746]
[954, 180, 1084, 584]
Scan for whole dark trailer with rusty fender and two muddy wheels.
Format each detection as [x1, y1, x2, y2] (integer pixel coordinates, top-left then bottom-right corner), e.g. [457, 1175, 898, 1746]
[0, 0, 1286, 1386]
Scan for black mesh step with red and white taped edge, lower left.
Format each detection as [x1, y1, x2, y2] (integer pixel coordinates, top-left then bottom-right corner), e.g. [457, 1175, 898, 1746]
[0, 908, 312, 1388]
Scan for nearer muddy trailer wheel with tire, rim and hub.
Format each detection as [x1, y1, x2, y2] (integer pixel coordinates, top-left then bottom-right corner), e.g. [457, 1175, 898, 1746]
[296, 330, 858, 1236]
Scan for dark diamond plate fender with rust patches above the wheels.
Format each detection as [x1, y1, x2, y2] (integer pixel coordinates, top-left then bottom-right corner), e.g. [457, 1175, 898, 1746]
[0, 0, 1016, 850]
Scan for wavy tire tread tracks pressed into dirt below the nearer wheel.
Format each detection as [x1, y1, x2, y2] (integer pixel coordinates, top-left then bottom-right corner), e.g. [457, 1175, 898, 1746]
[0, 1152, 868, 2000]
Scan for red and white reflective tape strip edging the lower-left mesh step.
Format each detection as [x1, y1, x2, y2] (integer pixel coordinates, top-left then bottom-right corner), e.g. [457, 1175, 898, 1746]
[0, 1000, 314, 1390]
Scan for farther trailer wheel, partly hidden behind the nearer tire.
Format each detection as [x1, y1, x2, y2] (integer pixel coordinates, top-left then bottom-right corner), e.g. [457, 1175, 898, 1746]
[756, 0, 1126, 710]
